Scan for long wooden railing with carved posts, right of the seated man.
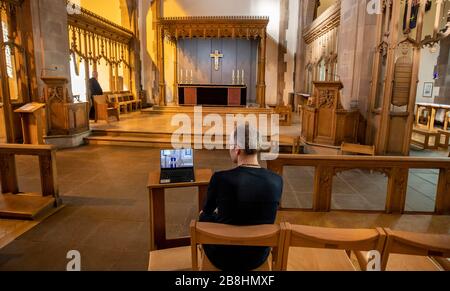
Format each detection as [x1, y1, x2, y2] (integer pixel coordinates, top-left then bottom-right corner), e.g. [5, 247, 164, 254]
[267, 155, 450, 214]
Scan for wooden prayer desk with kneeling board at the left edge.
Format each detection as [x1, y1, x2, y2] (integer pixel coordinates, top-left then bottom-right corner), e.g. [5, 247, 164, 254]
[0, 144, 61, 219]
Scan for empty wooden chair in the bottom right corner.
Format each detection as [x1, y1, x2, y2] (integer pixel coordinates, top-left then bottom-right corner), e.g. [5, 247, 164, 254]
[381, 229, 450, 271]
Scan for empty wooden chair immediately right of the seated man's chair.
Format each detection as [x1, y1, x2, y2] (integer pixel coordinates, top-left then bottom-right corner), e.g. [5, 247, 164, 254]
[282, 223, 386, 271]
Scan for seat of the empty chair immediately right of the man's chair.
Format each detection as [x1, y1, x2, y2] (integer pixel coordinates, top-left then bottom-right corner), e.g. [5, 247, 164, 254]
[287, 247, 356, 271]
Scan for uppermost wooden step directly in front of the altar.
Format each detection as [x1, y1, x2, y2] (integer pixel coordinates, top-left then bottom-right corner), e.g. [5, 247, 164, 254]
[142, 106, 274, 115]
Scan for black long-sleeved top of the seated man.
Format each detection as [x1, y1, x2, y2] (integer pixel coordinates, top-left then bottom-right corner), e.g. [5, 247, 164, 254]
[200, 167, 283, 271]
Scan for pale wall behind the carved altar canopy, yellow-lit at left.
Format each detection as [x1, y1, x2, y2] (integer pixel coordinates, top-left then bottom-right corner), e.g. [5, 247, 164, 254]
[141, 0, 299, 103]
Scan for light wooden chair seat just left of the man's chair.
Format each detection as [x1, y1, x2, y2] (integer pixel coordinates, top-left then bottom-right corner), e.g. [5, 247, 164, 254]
[148, 247, 192, 271]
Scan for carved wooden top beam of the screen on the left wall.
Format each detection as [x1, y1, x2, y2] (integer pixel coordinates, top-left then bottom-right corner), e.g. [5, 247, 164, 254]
[68, 7, 134, 44]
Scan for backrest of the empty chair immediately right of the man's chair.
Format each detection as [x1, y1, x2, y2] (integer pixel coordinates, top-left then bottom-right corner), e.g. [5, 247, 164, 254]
[282, 223, 386, 270]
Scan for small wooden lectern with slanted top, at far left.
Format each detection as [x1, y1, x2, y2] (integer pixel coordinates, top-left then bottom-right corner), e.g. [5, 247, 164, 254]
[14, 103, 45, 144]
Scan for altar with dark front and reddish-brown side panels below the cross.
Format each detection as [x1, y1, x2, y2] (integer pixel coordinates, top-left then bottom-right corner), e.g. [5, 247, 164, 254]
[178, 85, 247, 107]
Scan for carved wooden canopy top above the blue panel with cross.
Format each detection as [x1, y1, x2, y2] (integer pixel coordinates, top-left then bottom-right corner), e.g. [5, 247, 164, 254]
[158, 16, 269, 40]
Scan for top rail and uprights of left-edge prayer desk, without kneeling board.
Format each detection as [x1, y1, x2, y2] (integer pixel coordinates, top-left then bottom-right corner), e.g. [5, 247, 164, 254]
[0, 144, 61, 206]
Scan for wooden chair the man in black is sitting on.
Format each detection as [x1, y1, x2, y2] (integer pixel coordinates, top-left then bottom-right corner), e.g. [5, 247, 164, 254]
[191, 221, 285, 271]
